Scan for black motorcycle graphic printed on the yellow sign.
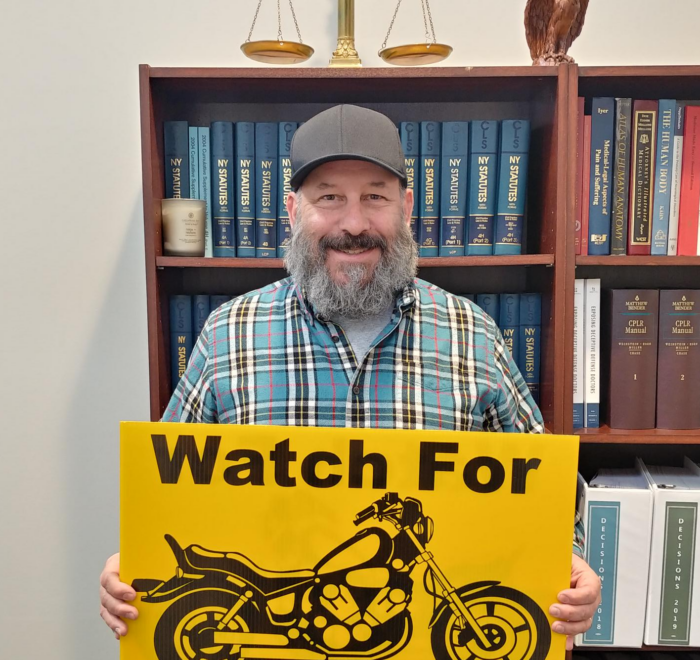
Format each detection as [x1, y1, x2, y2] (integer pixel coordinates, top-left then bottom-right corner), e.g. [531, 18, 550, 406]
[133, 493, 551, 660]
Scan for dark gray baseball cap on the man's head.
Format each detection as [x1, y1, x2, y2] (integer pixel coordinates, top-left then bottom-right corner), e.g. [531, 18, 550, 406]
[291, 105, 407, 190]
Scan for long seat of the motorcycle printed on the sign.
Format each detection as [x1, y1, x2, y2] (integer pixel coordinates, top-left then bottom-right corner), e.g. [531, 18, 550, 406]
[185, 545, 316, 595]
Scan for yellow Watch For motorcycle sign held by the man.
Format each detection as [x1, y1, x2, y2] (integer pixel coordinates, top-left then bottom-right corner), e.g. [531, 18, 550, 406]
[121, 423, 578, 660]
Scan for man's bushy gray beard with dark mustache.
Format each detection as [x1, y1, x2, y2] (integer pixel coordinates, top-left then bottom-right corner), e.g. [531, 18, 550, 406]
[284, 208, 418, 319]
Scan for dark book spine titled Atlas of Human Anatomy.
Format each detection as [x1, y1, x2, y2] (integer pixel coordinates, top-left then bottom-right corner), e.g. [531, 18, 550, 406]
[610, 99, 632, 255]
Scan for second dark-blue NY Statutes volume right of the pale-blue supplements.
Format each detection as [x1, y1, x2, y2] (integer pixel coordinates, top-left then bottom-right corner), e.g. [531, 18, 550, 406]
[235, 121, 255, 257]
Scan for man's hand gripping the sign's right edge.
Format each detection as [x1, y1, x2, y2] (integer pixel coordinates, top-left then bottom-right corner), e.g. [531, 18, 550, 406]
[549, 555, 600, 651]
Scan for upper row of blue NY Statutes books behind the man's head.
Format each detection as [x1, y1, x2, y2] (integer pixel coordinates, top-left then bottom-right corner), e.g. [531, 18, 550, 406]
[164, 119, 530, 258]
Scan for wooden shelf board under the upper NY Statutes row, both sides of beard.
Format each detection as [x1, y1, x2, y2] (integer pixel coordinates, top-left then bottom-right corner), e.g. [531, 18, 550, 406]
[156, 254, 554, 269]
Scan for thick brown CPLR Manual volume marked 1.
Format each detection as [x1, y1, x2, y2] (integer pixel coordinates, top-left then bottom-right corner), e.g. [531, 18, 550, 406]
[606, 289, 659, 429]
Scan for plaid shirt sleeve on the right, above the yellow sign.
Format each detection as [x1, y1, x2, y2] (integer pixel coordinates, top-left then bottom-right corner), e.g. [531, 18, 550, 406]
[484, 324, 544, 433]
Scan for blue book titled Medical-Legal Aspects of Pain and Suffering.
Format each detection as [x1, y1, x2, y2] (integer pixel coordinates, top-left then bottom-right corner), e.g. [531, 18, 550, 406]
[588, 97, 615, 256]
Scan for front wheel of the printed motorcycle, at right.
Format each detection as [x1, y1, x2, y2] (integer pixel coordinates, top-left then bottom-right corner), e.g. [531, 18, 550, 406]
[431, 586, 552, 660]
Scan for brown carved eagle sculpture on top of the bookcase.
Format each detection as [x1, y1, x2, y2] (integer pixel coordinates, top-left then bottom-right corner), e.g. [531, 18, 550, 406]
[525, 0, 589, 65]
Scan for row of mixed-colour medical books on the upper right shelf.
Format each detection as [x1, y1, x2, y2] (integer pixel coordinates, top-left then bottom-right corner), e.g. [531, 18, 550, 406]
[576, 98, 700, 256]
